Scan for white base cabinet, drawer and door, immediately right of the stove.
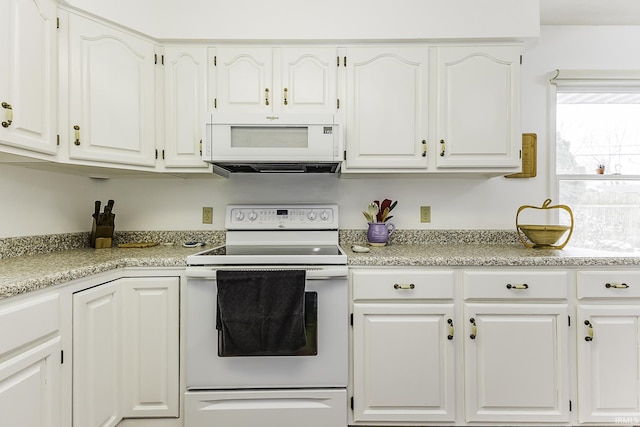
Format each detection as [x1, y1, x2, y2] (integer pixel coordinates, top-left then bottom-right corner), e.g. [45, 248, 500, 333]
[351, 269, 456, 425]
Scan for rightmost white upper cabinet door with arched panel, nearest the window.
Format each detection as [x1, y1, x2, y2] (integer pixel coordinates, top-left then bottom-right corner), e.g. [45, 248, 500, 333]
[436, 46, 522, 169]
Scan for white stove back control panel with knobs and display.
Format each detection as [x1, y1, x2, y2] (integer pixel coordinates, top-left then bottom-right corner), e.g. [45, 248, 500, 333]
[226, 205, 338, 230]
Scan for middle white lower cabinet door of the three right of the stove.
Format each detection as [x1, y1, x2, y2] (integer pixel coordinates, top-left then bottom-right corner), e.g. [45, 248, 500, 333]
[465, 304, 569, 422]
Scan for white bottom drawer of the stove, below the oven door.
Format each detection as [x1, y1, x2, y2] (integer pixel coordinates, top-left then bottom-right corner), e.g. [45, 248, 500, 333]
[184, 389, 347, 427]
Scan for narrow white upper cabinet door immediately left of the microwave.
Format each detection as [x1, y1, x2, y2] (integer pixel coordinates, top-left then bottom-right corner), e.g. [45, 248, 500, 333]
[162, 46, 208, 169]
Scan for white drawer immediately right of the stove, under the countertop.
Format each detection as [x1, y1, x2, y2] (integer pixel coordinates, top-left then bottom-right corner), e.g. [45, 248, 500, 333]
[351, 269, 455, 301]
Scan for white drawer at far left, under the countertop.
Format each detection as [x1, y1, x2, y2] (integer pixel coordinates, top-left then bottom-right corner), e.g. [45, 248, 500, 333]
[0, 293, 60, 355]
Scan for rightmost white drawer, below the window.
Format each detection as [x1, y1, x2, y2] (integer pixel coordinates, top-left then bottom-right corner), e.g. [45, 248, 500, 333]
[577, 270, 640, 299]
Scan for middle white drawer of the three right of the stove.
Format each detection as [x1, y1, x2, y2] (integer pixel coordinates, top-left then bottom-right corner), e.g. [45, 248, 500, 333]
[463, 270, 569, 300]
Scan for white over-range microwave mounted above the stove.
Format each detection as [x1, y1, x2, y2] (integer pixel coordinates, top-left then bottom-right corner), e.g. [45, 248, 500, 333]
[202, 112, 343, 176]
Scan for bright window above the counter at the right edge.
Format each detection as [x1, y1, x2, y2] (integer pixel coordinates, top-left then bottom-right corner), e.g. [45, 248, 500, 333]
[552, 72, 640, 252]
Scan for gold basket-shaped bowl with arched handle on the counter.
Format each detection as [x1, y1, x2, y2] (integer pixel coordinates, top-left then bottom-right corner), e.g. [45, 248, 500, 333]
[516, 199, 574, 249]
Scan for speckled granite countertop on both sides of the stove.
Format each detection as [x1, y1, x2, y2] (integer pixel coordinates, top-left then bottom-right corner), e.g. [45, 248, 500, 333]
[0, 230, 640, 299]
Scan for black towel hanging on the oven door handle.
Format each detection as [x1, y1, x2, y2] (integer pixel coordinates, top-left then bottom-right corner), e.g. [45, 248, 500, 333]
[216, 270, 306, 356]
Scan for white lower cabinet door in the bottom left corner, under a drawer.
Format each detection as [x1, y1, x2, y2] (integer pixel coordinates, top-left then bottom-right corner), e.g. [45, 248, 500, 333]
[0, 336, 61, 427]
